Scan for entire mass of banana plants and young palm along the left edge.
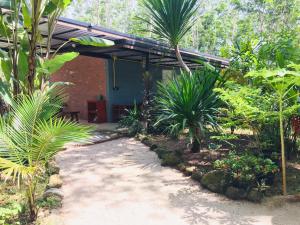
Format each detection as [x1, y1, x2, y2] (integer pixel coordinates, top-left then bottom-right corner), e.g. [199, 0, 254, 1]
[0, 0, 98, 222]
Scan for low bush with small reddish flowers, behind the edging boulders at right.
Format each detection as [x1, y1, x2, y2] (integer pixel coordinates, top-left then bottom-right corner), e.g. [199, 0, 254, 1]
[214, 151, 278, 188]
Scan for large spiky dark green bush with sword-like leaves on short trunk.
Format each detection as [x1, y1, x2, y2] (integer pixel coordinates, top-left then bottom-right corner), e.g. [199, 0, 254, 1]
[156, 68, 222, 152]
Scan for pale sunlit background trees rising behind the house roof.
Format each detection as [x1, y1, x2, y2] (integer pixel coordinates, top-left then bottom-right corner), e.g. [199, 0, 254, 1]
[64, 0, 299, 57]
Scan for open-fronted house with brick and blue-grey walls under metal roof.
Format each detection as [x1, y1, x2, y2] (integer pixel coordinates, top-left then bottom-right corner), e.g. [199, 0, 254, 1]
[0, 12, 229, 122]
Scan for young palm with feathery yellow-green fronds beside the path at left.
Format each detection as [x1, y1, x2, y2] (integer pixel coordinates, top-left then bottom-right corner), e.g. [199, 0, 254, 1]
[0, 88, 91, 221]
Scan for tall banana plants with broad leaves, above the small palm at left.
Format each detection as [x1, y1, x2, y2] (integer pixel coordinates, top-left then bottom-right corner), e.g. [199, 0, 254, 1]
[0, 0, 78, 100]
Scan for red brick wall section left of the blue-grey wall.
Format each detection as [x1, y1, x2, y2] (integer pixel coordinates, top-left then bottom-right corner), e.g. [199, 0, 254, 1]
[51, 56, 106, 120]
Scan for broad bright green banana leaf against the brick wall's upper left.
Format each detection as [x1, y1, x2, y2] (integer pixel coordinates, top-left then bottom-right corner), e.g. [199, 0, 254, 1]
[39, 52, 79, 75]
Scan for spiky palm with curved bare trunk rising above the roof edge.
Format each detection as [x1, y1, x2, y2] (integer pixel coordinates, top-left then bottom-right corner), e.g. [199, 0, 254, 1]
[142, 0, 199, 73]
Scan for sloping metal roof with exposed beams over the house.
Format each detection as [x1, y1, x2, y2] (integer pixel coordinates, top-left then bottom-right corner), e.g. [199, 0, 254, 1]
[0, 8, 229, 68]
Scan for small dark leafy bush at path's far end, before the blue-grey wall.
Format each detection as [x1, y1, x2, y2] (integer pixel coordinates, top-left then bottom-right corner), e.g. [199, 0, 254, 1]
[119, 103, 143, 136]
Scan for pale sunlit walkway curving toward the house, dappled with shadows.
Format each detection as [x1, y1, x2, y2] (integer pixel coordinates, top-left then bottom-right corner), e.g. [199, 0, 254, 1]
[55, 138, 300, 225]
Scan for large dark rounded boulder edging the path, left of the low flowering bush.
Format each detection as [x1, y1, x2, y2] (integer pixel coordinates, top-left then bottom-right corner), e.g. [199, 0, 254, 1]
[201, 170, 229, 193]
